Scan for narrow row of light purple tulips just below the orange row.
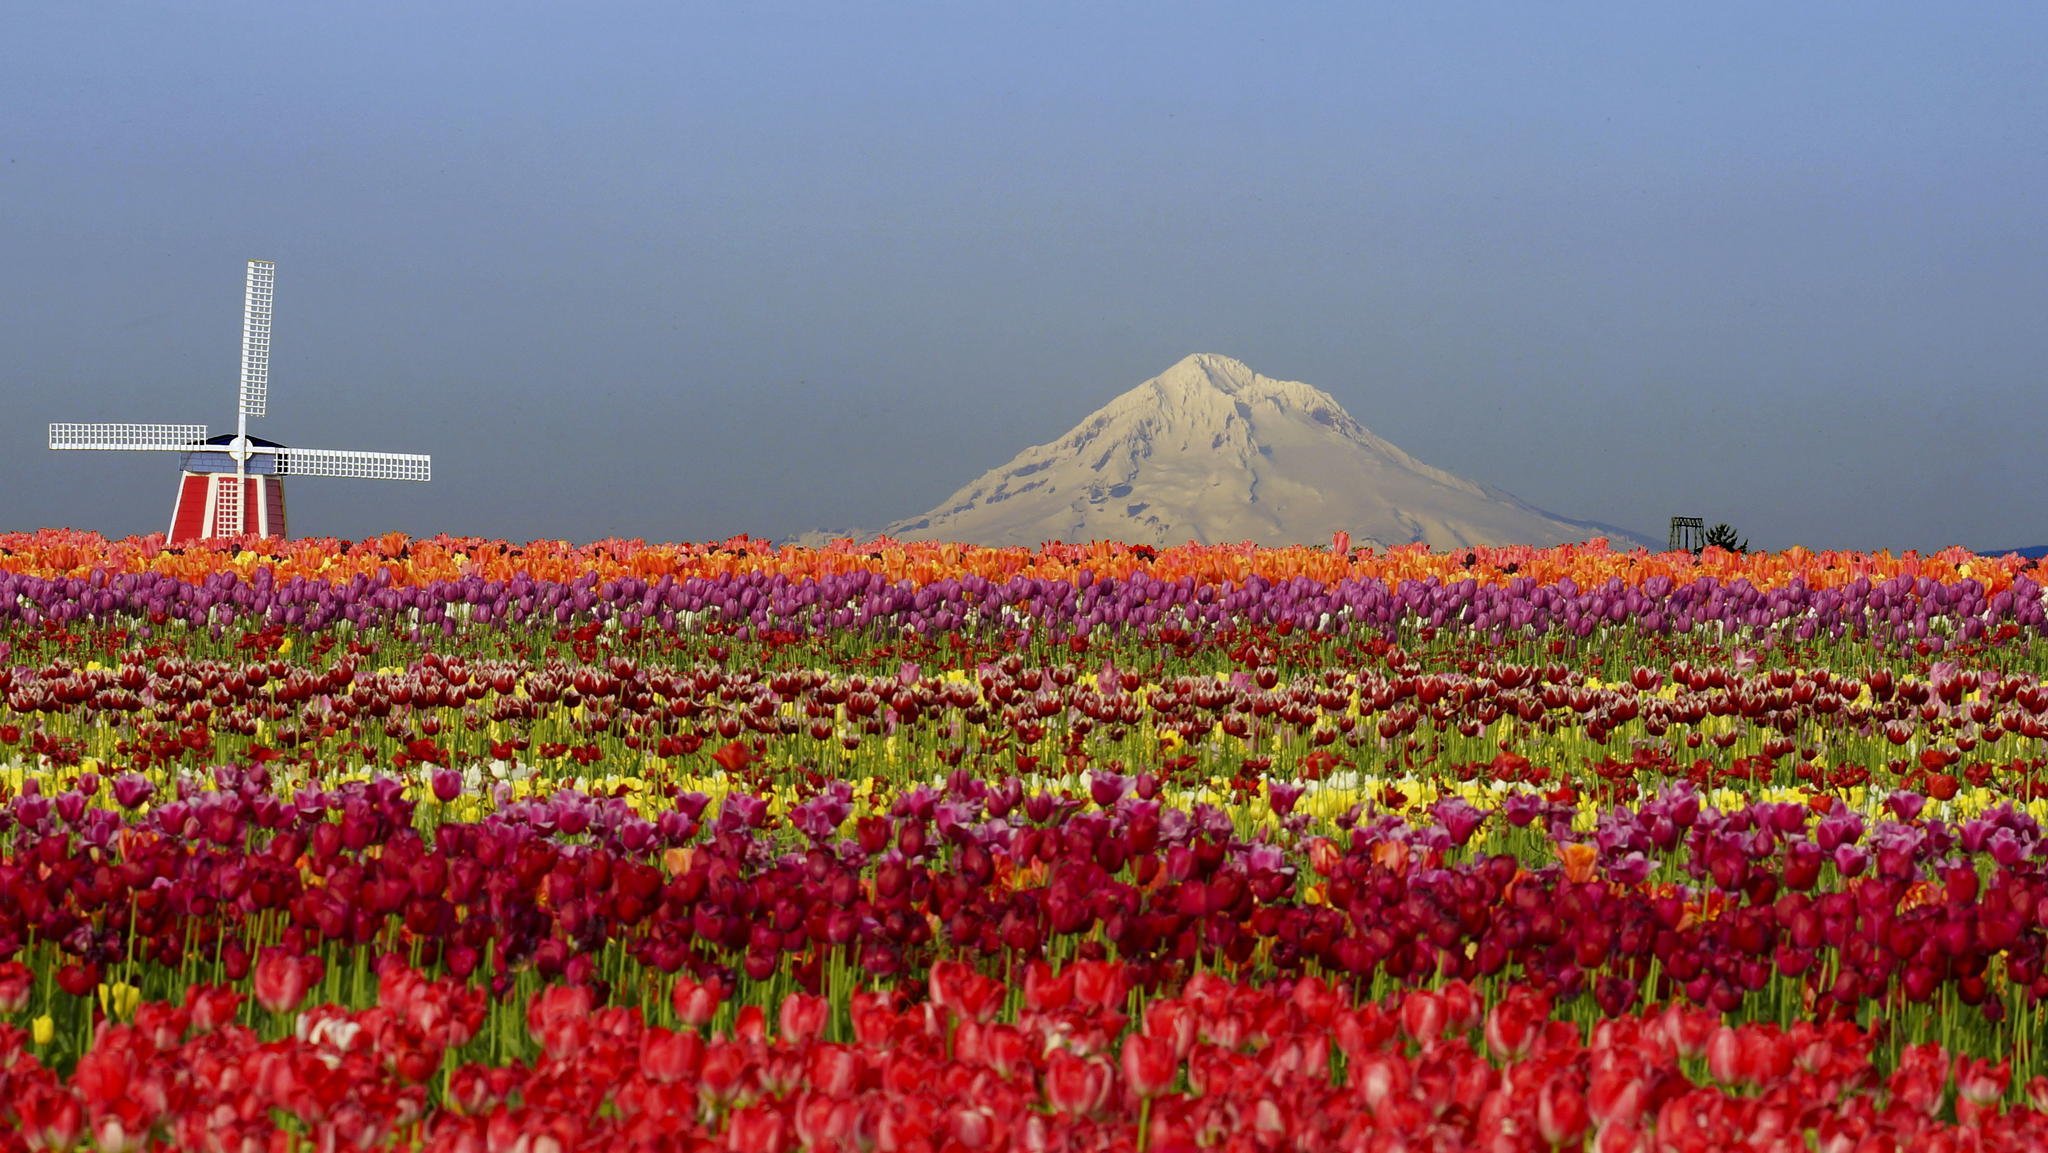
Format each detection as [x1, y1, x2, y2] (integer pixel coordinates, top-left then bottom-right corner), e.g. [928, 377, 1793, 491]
[0, 567, 2048, 645]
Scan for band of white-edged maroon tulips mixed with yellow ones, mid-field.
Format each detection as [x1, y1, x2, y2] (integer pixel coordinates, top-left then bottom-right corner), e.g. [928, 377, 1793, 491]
[12, 633, 2048, 803]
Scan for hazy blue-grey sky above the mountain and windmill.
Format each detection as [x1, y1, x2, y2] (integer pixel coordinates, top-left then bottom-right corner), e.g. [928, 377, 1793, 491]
[0, 4, 2048, 549]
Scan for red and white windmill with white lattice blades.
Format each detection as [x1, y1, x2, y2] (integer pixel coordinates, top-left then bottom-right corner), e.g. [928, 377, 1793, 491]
[49, 260, 432, 545]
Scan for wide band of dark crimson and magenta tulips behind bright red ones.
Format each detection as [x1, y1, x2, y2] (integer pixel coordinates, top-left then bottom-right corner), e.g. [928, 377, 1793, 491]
[0, 768, 2048, 1071]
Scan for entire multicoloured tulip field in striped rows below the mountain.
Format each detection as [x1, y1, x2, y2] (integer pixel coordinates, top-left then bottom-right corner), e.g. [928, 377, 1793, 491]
[12, 530, 2048, 1153]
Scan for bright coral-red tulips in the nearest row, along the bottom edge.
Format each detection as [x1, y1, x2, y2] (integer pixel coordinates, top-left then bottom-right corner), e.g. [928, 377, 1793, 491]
[0, 956, 2048, 1153]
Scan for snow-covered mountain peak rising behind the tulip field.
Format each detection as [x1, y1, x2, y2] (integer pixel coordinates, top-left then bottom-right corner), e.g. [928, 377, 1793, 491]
[885, 354, 1640, 549]
